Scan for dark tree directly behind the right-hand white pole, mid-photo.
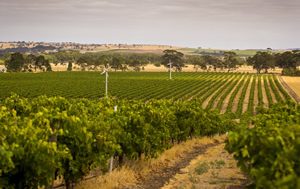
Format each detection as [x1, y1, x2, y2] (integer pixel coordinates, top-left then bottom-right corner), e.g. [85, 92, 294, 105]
[162, 49, 184, 71]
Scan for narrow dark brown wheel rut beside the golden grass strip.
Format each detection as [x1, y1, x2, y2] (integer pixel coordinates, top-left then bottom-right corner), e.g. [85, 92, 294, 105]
[134, 141, 221, 189]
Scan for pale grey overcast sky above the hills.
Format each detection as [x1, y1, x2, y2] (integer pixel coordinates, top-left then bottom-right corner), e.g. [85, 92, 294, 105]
[0, 0, 300, 49]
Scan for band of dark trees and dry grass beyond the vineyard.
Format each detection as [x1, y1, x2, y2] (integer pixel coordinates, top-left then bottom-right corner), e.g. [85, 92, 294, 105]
[5, 50, 300, 75]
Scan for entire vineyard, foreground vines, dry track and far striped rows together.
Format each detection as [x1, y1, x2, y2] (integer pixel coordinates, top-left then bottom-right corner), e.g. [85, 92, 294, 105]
[0, 72, 300, 189]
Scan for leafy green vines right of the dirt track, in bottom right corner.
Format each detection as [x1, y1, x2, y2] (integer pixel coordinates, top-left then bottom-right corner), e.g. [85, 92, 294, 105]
[226, 103, 300, 189]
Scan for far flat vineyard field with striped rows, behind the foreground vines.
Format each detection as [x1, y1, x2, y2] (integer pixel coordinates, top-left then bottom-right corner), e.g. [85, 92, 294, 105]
[0, 72, 290, 115]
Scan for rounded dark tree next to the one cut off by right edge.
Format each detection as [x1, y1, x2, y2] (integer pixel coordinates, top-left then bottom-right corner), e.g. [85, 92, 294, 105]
[247, 52, 275, 73]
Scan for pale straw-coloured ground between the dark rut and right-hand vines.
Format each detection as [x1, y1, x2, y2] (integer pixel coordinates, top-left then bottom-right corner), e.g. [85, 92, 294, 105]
[162, 143, 248, 189]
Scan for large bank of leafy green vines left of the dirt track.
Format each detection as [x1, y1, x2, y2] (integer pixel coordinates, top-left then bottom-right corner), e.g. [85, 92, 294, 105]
[0, 95, 235, 188]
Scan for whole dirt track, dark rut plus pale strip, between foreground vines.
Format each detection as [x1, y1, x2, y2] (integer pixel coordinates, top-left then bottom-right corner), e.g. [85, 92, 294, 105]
[131, 136, 248, 189]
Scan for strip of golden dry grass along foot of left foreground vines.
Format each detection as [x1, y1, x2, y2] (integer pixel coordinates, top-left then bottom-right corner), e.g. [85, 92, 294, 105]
[76, 136, 224, 189]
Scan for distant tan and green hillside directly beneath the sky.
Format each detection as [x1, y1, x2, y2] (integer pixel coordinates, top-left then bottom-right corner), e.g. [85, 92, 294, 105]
[0, 41, 292, 57]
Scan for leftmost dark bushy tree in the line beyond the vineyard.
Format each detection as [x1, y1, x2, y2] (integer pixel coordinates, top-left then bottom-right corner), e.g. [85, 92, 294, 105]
[5, 53, 25, 72]
